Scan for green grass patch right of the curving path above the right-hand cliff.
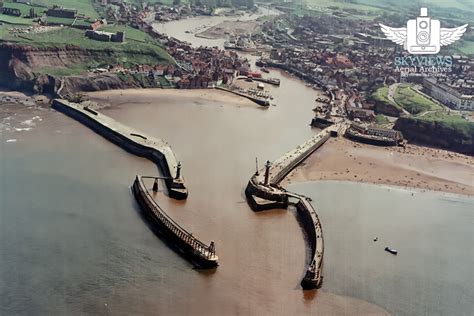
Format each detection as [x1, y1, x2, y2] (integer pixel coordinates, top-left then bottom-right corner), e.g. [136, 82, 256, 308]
[393, 85, 441, 114]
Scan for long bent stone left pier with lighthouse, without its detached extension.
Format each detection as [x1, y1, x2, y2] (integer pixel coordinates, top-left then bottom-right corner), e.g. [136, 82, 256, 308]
[52, 99, 188, 200]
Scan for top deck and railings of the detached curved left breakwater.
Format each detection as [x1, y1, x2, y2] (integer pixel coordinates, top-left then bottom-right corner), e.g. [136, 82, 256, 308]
[135, 176, 216, 259]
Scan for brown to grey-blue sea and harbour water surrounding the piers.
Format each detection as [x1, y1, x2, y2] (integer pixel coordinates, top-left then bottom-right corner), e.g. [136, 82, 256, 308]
[0, 8, 474, 315]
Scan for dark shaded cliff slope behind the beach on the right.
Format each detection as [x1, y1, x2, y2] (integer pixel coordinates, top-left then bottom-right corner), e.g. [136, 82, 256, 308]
[394, 117, 474, 155]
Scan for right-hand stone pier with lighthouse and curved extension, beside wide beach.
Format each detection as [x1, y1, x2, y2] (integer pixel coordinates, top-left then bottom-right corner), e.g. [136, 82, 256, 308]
[245, 123, 344, 289]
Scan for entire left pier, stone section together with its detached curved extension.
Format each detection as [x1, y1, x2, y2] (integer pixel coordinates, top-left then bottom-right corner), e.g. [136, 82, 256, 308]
[52, 99, 218, 269]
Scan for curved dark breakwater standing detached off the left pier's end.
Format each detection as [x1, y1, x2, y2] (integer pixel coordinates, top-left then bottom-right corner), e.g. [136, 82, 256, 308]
[132, 176, 218, 269]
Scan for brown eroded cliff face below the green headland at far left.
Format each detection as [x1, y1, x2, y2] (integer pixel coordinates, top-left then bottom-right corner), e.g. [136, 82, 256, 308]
[0, 43, 167, 95]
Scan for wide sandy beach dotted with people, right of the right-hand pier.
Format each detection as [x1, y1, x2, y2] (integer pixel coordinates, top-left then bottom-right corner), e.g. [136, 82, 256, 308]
[283, 137, 474, 195]
